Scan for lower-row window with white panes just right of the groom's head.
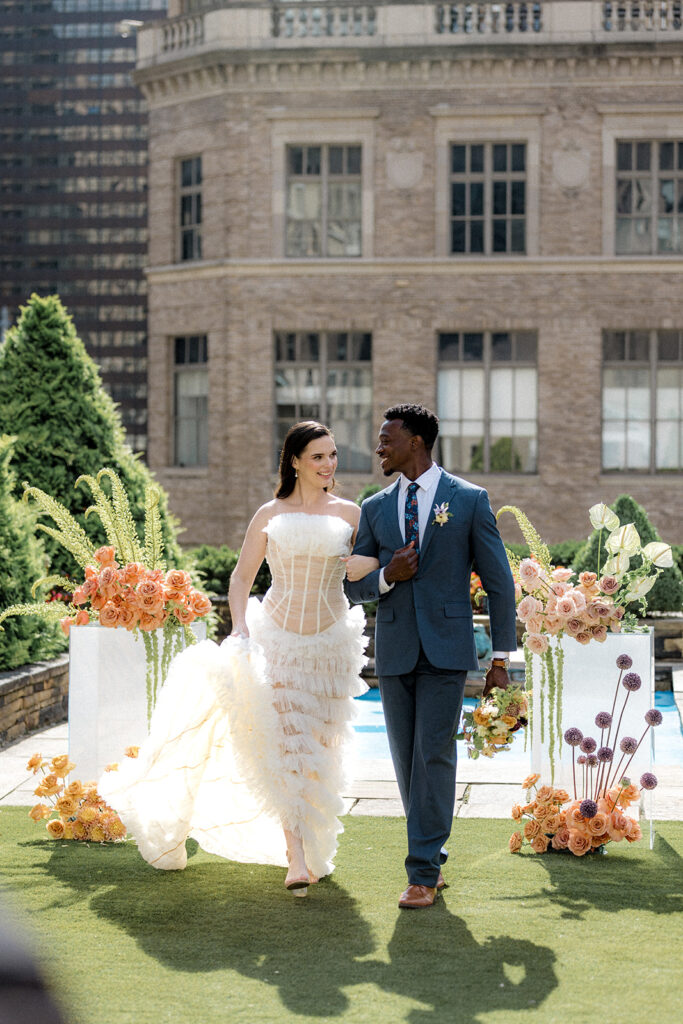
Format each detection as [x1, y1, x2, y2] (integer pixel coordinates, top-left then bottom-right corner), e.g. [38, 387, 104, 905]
[437, 331, 538, 473]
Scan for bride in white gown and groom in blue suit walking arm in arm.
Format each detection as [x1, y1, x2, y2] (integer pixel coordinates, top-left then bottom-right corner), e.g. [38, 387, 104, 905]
[100, 404, 516, 908]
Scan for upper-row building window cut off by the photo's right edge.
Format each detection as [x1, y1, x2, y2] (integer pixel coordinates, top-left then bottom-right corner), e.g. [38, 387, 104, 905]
[616, 140, 683, 255]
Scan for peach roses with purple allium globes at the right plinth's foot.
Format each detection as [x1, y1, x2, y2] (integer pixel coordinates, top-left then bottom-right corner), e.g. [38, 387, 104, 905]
[509, 654, 661, 857]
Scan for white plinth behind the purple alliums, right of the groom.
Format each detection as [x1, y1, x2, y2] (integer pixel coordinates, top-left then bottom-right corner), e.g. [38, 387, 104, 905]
[527, 630, 654, 796]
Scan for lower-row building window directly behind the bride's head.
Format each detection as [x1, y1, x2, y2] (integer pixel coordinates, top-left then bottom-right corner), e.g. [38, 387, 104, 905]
[275, 331, 374, 473]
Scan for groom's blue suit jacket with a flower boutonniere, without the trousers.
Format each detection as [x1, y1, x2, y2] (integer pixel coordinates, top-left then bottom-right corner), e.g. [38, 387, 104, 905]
[345, 470, 517, 676]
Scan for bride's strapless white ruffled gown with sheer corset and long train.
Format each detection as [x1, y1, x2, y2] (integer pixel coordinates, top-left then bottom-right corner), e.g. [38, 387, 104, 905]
[99, 513, 367, 876]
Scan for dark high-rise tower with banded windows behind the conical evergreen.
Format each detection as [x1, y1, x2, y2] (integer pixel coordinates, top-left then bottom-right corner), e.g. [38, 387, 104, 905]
[0, 0, 167, 451]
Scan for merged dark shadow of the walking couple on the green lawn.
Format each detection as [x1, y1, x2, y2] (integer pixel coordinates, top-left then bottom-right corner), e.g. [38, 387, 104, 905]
[15, 841, 557, 1024]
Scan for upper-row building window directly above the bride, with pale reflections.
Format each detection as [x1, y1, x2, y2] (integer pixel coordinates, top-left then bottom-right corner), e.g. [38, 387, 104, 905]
[285, 145, 361, 257]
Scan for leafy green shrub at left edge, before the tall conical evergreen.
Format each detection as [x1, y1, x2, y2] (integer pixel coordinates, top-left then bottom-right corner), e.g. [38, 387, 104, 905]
[0, 436, 66, 672]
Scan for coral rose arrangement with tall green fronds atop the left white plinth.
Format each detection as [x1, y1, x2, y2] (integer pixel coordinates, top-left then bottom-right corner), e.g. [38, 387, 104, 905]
[0, 468, 211, 718]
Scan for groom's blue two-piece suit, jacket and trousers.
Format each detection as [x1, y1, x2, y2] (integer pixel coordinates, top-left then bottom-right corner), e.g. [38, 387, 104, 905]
[346, 470, 517, 887]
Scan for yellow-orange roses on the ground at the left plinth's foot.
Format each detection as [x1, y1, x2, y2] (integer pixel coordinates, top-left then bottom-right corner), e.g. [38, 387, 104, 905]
[27, 746, 137, 843]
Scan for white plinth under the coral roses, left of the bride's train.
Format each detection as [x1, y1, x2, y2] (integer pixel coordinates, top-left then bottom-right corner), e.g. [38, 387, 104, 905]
[69, 623, 206, 781]
